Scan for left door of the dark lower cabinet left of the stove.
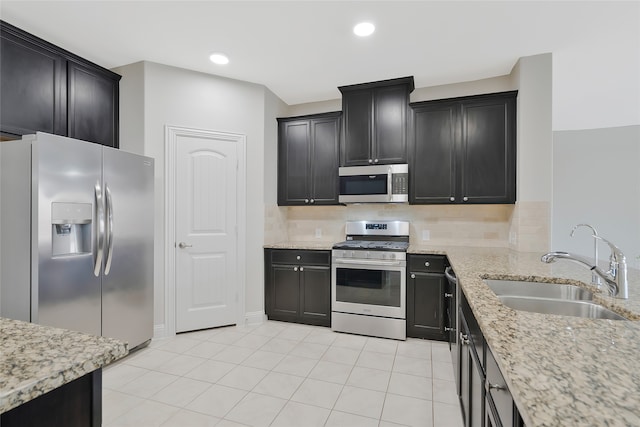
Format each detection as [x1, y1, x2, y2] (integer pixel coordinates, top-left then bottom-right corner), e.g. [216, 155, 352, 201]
[269, 264, 300, 321]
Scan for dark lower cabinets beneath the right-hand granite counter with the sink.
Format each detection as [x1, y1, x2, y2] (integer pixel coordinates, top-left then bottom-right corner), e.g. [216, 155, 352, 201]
[454, 288, 524, 427]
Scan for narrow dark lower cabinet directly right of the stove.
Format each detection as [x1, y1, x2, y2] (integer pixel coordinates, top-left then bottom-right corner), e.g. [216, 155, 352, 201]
[407, 254, 452, 341]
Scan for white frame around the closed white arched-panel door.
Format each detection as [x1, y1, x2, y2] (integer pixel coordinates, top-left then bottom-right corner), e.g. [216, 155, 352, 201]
[164, 125, 247, 336]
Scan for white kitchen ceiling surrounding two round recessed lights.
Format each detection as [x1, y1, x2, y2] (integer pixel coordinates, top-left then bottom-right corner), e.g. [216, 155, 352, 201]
[0, 0, 640, 128]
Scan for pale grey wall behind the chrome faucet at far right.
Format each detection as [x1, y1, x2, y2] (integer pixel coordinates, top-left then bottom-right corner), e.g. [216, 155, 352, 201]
[552, 125, 640, 268]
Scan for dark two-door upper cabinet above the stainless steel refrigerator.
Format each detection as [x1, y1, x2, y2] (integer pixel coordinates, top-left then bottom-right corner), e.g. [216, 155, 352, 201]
[0, 21, 120, 148]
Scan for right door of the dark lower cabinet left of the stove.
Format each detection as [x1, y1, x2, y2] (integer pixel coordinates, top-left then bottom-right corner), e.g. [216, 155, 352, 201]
[300, 266, 331, 326]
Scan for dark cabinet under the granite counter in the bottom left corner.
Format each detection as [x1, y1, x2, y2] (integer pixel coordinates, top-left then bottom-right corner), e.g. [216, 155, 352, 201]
[0, 369, 102, 427]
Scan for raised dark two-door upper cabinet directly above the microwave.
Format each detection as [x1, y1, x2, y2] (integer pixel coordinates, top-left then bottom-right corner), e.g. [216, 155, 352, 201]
[338, 77, 414, 166]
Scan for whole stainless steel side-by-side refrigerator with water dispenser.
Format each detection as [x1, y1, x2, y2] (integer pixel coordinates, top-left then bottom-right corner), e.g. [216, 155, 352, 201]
[0, 132, 154, 348]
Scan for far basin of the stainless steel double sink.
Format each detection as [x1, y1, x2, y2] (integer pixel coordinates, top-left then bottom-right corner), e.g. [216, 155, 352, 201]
[484, 279, 593, 301]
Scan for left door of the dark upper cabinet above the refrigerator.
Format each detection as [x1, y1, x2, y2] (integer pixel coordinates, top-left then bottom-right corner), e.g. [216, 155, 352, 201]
[0, 23, 67, 136]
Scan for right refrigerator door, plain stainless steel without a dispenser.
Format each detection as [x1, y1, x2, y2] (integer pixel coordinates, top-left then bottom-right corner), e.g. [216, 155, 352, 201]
[102, 148, 154, 348]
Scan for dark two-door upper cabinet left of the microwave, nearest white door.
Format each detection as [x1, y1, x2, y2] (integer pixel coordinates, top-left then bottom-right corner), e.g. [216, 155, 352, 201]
[278, 112, 341, 206]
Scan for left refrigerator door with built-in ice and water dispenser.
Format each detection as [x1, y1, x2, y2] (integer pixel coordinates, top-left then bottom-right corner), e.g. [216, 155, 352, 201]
[31, 133, 102, 335]
